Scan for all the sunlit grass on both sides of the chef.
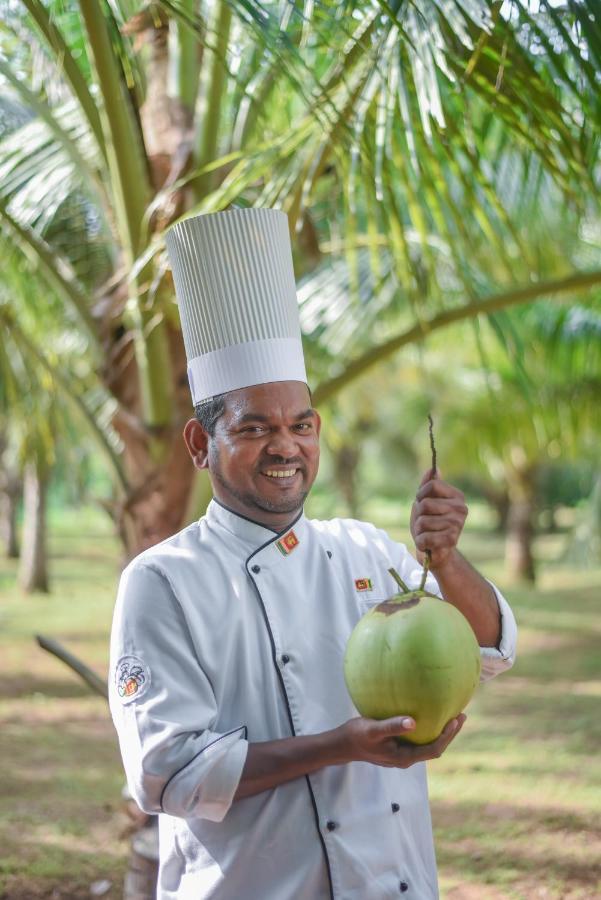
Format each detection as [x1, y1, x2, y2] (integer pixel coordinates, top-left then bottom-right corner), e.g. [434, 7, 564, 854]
[0, 504, 601, 900]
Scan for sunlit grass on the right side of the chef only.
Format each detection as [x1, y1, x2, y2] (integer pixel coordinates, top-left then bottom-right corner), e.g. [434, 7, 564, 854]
[430, 564, 601, 900]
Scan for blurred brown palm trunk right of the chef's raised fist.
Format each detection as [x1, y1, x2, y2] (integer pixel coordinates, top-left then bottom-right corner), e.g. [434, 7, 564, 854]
[505, 466, 536, 583]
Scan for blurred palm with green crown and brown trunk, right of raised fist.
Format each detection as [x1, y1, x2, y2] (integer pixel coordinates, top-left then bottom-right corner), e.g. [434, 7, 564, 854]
[404, 297, 601, 581]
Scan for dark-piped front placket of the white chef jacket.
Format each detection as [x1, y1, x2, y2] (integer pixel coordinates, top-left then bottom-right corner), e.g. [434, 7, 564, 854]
[245, 522, 340, 900]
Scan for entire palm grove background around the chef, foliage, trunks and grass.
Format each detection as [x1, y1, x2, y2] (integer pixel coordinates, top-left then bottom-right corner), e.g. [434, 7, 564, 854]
[0, 0, 601, 900]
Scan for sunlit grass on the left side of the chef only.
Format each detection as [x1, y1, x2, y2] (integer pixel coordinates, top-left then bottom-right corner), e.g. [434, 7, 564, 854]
[0, 510, 128, 900]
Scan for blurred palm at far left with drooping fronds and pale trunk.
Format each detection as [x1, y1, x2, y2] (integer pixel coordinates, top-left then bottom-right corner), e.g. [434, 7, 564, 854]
[0, 240, 125, 592]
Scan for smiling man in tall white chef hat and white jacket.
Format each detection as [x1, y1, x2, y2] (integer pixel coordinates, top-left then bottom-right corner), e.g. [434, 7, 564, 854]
[111, 210, 515, 900]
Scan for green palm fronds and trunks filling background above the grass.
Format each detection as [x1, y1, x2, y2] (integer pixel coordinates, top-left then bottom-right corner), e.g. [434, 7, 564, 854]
[0, 0, 601, 589]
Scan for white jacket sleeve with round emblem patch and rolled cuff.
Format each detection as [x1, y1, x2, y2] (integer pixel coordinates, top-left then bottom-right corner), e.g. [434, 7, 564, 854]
[109, 561, 248, 822]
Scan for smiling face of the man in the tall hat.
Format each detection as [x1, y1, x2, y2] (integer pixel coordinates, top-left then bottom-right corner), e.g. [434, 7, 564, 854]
[198, 381, 320, 530]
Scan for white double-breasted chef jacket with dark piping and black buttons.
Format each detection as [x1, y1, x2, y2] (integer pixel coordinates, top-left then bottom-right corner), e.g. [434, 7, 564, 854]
[110, 500, 516, 900]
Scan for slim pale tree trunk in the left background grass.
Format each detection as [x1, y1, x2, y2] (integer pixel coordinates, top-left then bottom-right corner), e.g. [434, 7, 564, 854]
[19, 460, 49, 594]
